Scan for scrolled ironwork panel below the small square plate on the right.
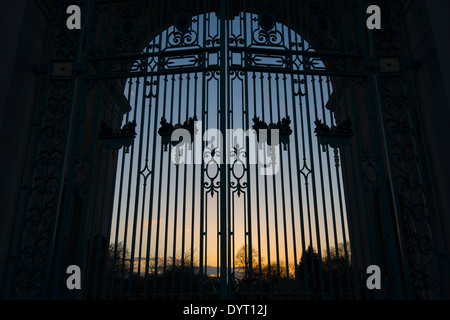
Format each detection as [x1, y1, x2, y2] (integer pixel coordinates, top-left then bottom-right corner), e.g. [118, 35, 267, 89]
[381, 75, 440, 299]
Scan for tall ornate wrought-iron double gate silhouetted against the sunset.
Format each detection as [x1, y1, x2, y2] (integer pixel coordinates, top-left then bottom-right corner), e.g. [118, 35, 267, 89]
[4, 0, 445, 299]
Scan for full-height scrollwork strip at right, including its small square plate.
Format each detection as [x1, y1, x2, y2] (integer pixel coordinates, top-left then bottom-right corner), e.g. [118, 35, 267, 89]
[374, 1, 441, 299]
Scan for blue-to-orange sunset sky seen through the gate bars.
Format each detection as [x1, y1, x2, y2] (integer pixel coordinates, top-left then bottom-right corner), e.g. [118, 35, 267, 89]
[107, 14, 349, 278]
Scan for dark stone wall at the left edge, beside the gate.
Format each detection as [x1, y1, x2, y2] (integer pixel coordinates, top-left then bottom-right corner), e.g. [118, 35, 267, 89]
[0, 0, 48, 292]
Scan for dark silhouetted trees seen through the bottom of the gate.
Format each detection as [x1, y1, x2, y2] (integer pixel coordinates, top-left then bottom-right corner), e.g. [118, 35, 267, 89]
[84, 243, 366, 299]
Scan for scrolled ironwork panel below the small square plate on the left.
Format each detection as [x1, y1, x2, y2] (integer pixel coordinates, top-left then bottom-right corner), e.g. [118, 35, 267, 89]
[14, 81, 73, 299]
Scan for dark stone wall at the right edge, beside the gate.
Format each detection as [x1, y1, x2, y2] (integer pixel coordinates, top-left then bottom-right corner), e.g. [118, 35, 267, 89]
[405, 0, 450, 250]
